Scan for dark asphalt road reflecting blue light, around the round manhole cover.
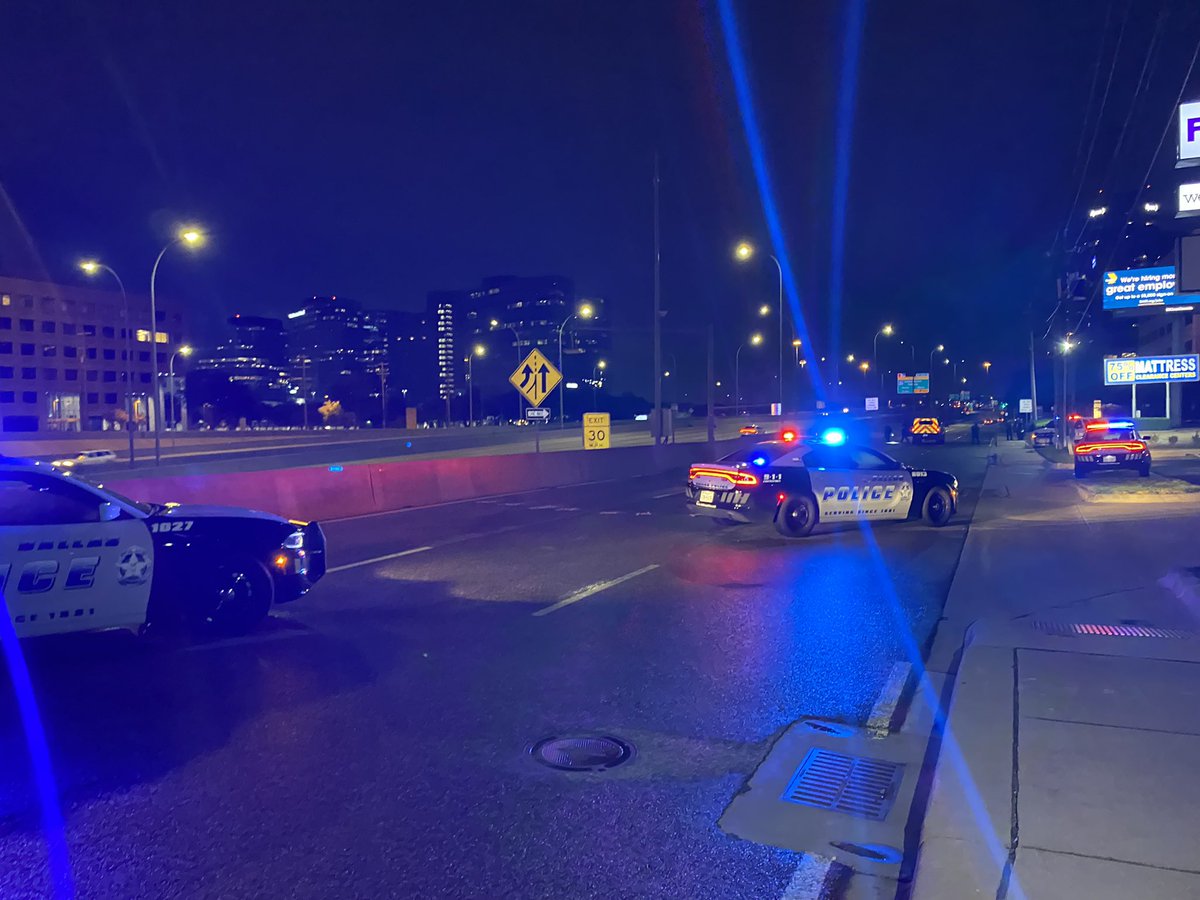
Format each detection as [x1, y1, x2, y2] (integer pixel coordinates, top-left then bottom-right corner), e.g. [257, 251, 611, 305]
[0, 426, 986, 898]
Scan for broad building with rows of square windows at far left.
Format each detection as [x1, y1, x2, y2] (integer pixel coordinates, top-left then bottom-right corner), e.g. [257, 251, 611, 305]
[0, 277, 184, 432]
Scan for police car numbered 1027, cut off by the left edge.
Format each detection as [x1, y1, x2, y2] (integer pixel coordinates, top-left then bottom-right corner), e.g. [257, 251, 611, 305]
[0, 458, 325, 637]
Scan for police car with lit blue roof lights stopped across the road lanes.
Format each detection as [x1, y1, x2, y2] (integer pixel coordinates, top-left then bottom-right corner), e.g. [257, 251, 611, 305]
[686, 428, 959, 538]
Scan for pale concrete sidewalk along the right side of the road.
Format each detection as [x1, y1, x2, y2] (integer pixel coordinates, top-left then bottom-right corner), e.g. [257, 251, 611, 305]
[912, 442, 1200, 900]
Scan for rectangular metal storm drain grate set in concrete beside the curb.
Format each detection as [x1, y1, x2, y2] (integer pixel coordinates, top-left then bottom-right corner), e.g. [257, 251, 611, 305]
[781, 748, 904, 822]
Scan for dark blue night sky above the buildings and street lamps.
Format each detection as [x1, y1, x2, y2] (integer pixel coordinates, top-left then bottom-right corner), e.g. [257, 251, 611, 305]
[0, 0, 1198, 400]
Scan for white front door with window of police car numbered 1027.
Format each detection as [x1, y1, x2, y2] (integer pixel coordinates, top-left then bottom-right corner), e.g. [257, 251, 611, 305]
[0, 469, 154, 637]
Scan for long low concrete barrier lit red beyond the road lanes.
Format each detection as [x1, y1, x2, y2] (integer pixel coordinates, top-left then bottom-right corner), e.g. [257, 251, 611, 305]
[104, 439, 752, 520]
